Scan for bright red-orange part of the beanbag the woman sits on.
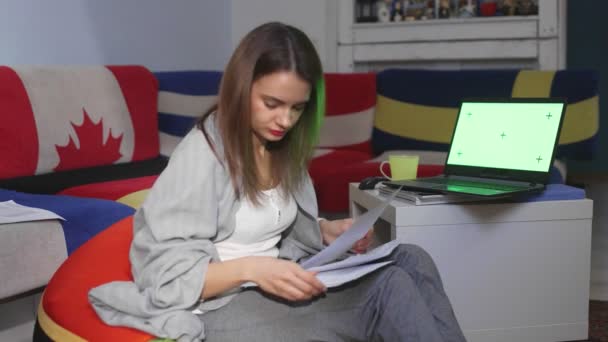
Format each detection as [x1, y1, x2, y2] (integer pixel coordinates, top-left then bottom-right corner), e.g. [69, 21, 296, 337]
[42, 217, 153, 341]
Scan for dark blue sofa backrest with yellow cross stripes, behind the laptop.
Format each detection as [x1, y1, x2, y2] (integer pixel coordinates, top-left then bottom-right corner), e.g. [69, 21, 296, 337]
[372, 69, 599, 160]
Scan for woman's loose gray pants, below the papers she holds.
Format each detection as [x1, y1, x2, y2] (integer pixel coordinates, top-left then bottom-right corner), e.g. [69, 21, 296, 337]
[201, 245, 465, 342]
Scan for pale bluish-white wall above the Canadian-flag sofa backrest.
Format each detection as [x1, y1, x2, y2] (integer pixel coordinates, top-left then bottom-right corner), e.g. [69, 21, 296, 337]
[0, 0, 232, 71]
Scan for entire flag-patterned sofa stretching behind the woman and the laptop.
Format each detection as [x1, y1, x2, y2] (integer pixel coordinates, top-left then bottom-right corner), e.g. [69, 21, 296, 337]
[0, 65, 599, 295]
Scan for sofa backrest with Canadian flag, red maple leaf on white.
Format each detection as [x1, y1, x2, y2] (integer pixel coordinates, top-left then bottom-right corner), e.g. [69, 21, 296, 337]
[0, 66, 159, 179]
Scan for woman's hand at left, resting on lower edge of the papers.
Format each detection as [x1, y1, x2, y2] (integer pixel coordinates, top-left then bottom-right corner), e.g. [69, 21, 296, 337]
[247, 256, 327, 301]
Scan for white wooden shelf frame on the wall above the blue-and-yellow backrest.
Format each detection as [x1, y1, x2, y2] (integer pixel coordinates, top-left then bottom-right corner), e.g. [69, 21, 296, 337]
[337, 0, 566, 72]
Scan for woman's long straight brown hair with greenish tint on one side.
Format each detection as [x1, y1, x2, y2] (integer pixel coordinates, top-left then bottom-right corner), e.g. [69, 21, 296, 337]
[198, 22, 325, 204]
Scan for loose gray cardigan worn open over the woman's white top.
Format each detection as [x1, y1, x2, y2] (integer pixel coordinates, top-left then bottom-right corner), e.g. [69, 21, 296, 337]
[89, 116, 323, 341]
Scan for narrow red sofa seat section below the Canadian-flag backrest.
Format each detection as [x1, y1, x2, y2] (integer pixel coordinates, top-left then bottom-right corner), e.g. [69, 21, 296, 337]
[59, 175, 158, 201]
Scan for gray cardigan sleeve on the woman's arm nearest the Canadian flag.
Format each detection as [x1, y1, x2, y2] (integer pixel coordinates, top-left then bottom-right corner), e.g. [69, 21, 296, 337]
[129, 131, 218, 308]
